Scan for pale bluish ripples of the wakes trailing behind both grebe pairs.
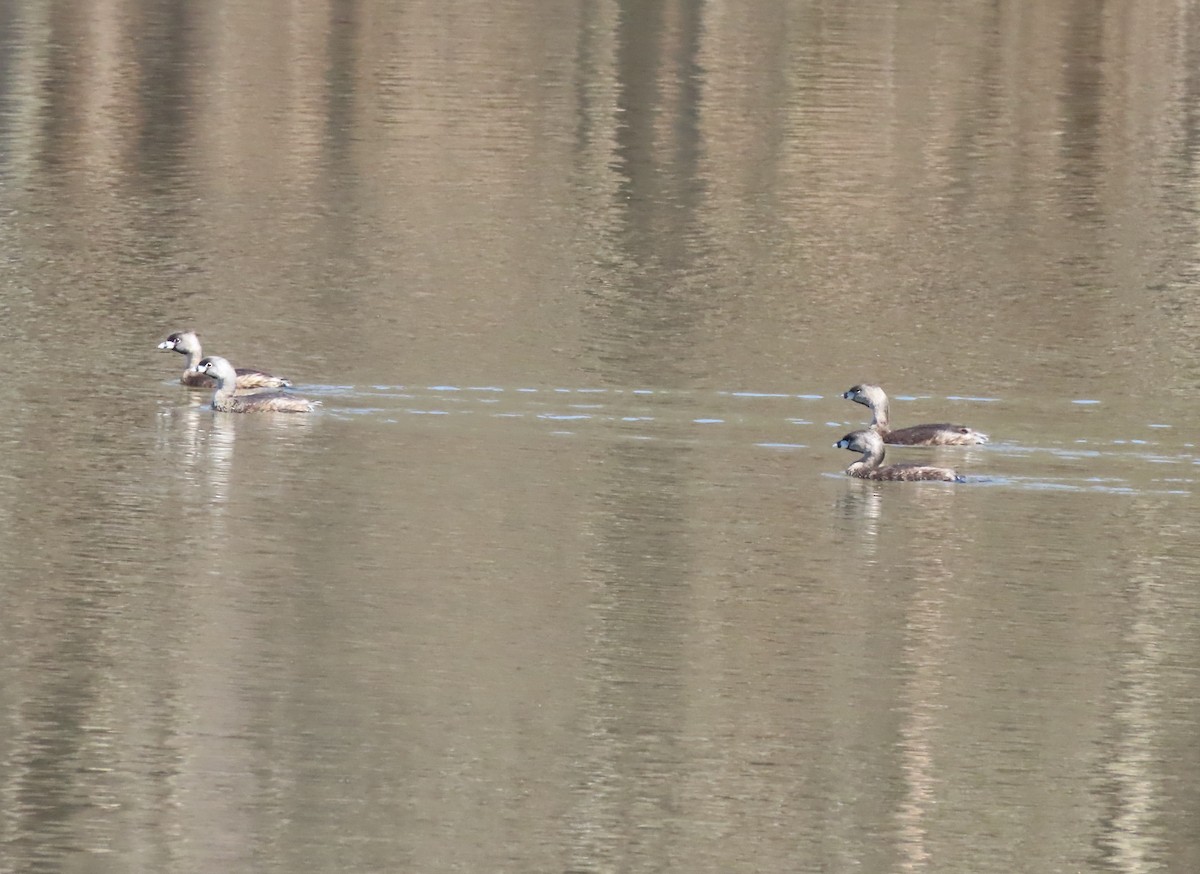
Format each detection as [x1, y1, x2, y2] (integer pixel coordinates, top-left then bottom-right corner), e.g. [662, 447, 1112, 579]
[288, 383, 1200, 495]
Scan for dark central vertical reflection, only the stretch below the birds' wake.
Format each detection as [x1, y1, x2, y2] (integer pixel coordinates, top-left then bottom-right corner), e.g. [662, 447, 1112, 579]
[572, 443, 692, 868]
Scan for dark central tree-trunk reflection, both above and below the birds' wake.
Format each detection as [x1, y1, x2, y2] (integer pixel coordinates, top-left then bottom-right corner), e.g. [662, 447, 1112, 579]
[574, 2, 707, 867]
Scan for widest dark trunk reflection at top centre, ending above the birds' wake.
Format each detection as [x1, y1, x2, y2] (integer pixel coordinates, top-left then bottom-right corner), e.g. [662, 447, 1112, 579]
[592, 4, 712, 387]
